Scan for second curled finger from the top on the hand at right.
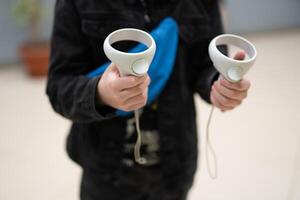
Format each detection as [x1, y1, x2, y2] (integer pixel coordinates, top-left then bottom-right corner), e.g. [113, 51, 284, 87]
[213, 81, 247, 100]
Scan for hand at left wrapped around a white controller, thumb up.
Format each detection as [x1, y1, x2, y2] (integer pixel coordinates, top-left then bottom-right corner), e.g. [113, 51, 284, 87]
[98, 64, 150, 112]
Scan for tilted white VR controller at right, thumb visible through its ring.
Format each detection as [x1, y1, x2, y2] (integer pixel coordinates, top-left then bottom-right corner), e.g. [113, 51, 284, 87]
[208, 34, 256, 82]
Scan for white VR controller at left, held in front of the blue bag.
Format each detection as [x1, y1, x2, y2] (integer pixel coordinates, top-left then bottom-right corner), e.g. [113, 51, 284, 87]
[103, 28, 156, 76]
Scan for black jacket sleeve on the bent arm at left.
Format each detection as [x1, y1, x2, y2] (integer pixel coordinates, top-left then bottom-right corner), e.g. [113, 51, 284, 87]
[46, 0, 112, 122]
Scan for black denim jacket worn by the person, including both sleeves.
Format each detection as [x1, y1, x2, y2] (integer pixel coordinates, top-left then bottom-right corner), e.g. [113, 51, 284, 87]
[47, 0, 222, 188]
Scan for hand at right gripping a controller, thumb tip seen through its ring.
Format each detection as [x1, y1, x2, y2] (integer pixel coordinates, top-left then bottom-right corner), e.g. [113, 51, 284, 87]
[210, 51, 250, 111]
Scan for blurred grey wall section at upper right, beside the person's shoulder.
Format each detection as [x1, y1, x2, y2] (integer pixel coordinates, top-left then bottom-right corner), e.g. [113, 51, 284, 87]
[225, 0, 300, 33]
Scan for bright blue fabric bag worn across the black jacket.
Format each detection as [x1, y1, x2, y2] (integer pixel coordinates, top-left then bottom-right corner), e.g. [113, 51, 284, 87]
[87, 17, 178, 116]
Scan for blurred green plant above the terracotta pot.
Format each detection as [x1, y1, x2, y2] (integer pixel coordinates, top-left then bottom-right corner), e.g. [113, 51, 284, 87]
[13, 0, 46, 42]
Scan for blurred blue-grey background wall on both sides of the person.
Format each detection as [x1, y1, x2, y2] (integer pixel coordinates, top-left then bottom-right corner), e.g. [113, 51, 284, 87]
[0, 0, 300, 65]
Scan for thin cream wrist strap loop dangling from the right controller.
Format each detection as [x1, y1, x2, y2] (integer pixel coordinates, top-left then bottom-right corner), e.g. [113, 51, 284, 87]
[205, 106, 218, 179]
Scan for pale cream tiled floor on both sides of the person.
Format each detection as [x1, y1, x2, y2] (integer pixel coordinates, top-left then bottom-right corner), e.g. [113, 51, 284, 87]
[0, 30, 300, 200]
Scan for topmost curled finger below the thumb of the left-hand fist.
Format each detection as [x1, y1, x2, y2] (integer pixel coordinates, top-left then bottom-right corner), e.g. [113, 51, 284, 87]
[113, 75, 149, 90]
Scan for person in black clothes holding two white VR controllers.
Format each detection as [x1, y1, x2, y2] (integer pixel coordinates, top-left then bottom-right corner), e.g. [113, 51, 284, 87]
[47, 0, 250, 200]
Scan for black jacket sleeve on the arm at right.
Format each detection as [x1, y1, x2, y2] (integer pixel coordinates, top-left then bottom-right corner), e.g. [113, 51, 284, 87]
[194, 1, 226, 103]
